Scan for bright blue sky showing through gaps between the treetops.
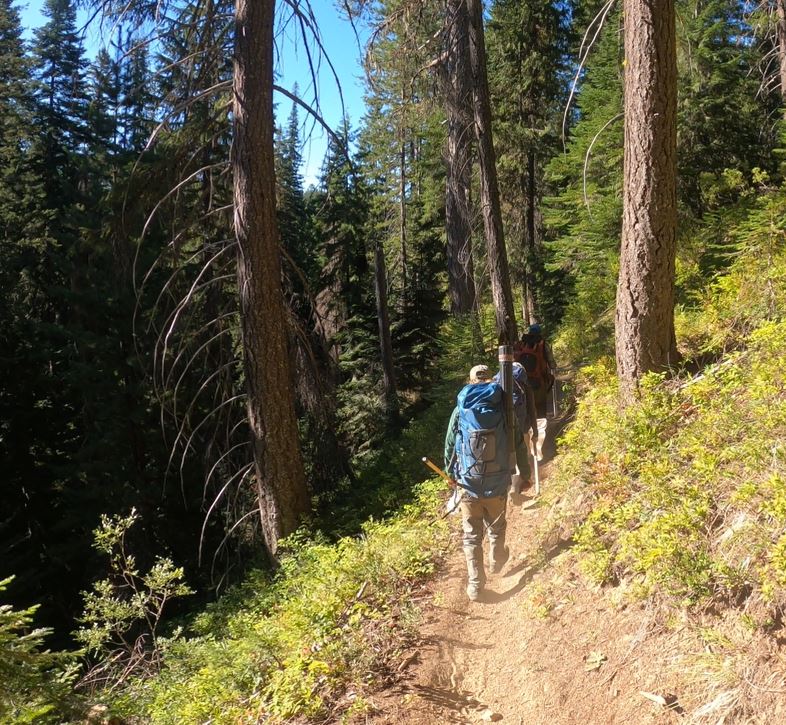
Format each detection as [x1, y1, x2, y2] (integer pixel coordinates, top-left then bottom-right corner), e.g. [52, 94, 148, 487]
[17, 0, 365, 186]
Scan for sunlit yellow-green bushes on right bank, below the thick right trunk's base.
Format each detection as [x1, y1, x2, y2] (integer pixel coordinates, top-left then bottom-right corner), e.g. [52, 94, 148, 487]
[552, 314, 786, 607]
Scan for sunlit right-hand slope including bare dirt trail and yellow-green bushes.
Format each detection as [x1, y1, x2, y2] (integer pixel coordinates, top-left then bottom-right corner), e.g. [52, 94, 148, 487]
[369, 322, 786, 725]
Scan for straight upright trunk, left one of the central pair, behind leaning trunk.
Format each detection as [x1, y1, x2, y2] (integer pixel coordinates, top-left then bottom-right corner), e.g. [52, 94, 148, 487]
[441, 0, 475, 315]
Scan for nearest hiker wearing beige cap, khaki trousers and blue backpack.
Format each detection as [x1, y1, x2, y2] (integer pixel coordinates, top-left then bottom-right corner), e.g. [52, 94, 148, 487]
[445, 365, 520, 601]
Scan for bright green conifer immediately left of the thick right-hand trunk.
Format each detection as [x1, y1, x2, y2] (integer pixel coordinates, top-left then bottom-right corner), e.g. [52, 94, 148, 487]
[541, 10, 623, 355]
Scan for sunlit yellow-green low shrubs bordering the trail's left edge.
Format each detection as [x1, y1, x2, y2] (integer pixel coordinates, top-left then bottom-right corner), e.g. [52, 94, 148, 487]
[103, 481, 446, 723]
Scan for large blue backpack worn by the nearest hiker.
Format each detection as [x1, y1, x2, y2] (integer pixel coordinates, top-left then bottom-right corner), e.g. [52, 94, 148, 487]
[456, 383, 511, 498]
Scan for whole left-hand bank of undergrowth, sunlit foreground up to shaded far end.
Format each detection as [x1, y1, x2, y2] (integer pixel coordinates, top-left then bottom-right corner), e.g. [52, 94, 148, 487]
[92, 317, 484, 723]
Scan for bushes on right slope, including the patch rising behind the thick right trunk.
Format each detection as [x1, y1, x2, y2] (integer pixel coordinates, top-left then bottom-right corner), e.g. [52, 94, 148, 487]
[551, 180, 786, 604]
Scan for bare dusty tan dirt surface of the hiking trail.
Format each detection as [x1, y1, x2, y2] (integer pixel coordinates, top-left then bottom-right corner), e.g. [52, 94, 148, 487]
[363, 412, 684, 725]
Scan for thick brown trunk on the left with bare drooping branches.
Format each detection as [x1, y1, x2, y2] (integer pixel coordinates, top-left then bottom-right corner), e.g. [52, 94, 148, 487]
[231, 0, 310, 557]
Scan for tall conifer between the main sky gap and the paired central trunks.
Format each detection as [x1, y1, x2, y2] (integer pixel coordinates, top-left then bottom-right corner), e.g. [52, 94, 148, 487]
[360, 0, 448, 398]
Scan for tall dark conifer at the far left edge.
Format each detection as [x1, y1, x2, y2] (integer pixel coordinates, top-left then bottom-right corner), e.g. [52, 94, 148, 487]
[0, 0, 55, 618]
